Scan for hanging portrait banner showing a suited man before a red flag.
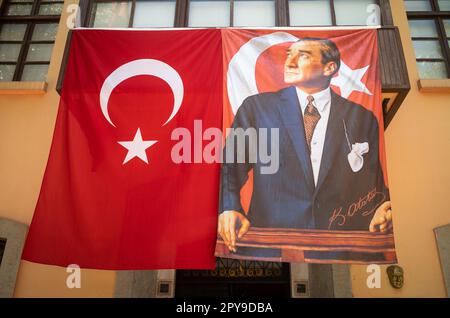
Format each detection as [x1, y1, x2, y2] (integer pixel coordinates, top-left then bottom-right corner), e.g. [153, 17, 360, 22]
[215, 29, 396, 264]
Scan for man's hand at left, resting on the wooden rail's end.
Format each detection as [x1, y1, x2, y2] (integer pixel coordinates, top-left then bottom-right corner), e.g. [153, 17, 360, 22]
[217, 211, 250, 252]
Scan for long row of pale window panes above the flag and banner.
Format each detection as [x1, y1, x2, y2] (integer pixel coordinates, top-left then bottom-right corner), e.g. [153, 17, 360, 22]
[88, 0, 381, 28]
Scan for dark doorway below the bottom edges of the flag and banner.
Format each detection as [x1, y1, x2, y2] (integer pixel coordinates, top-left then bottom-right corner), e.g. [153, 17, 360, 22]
[175, 258, 290, 298]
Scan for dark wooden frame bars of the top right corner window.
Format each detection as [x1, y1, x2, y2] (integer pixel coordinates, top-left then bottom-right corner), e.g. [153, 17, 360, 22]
[406, 0, 450, 79]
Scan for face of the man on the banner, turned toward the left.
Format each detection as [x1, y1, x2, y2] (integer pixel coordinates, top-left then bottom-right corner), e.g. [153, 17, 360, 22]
[284, 41, 332, 87]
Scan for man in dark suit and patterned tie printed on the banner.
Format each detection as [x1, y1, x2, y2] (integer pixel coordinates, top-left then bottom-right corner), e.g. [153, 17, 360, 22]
[218, 38, 392, 251]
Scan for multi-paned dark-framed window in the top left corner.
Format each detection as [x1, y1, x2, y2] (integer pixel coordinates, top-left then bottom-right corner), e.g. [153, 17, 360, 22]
[0, 0, 63, 81]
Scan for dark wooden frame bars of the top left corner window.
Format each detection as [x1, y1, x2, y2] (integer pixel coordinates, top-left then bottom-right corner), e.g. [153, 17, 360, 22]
[0, 0, 64, 82]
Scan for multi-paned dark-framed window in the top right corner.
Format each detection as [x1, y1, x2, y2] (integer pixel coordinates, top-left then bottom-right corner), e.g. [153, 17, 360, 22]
[405, 0, 450, 79]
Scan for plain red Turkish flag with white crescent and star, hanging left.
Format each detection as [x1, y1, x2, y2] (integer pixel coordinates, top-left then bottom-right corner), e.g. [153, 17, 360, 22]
[23, 29, 222, 270]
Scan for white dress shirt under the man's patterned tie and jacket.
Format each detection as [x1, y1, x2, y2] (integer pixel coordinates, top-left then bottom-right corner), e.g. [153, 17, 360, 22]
[296, 87, 331, 185]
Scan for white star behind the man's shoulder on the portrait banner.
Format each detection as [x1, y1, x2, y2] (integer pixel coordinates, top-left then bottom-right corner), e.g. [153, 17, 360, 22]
[331, 60, 372, 98]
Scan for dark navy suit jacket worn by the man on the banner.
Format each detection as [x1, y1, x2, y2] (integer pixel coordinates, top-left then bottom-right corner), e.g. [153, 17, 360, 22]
[220, 87, 389, 230]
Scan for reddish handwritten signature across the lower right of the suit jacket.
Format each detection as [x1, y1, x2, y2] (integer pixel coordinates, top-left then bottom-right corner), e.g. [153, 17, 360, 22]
[328, 188, 386, 229]
